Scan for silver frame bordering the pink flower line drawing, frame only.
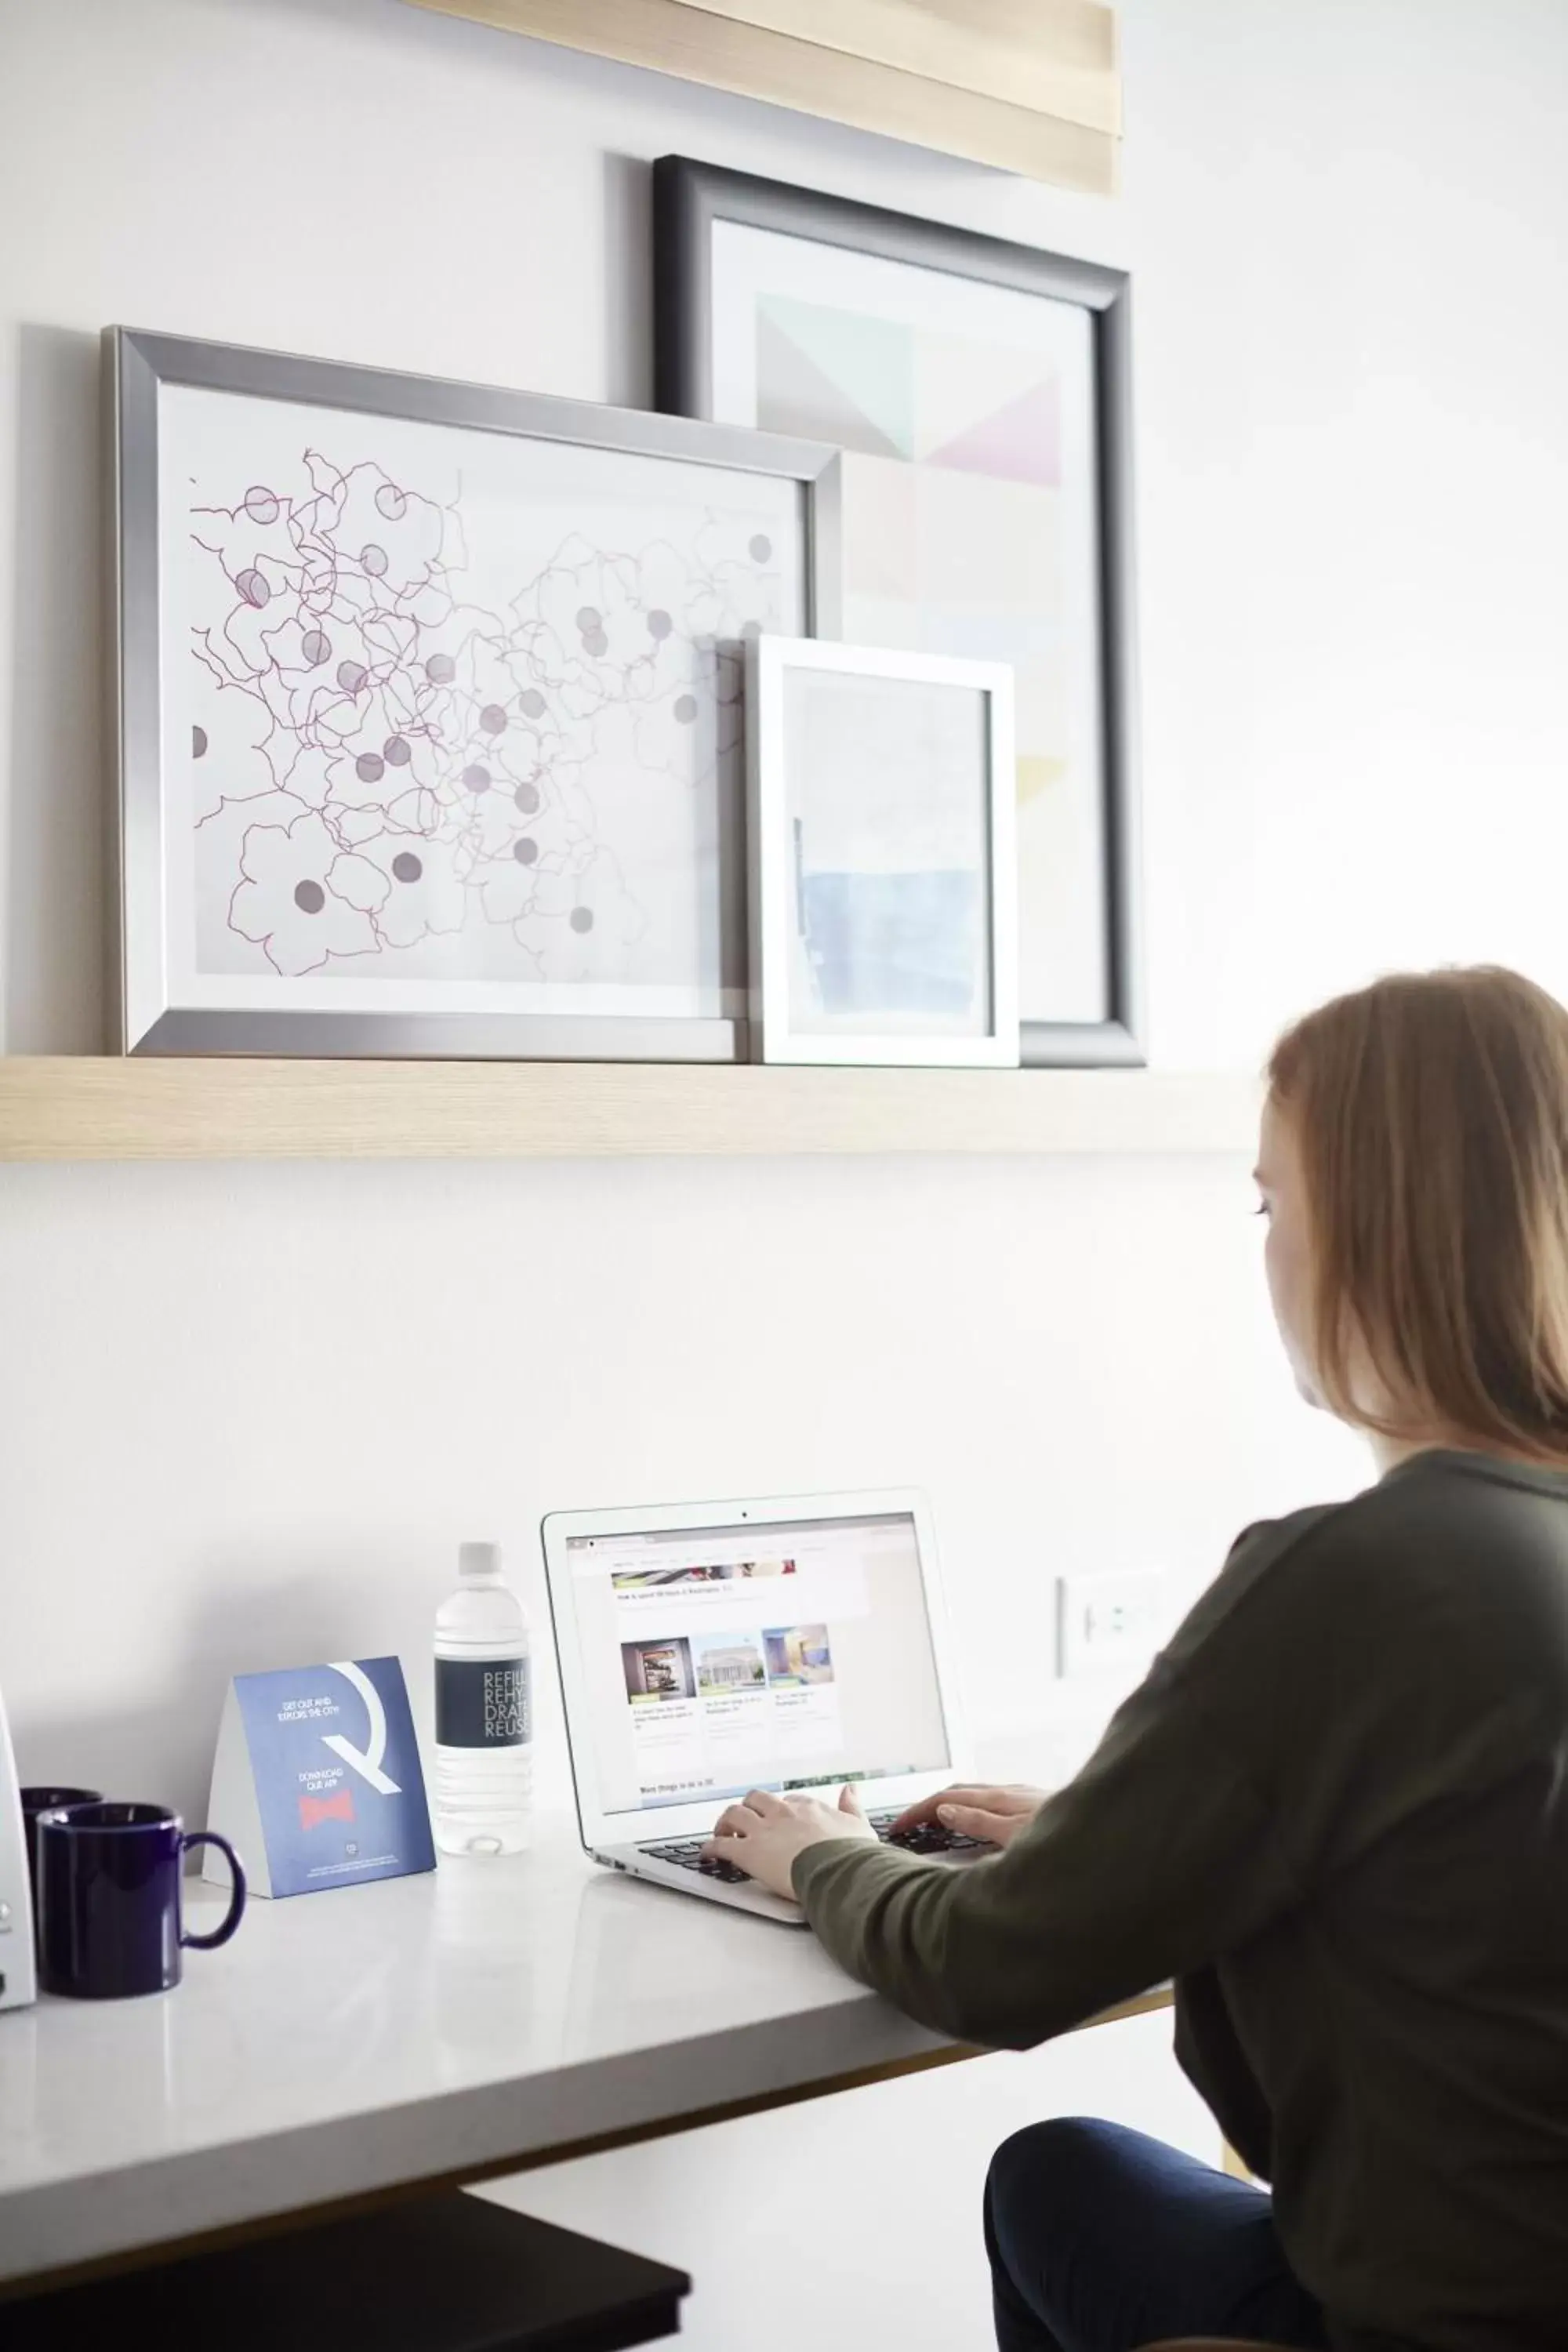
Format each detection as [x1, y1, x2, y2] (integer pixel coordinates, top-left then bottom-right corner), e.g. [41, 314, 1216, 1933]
[103, 327, 837, 1063]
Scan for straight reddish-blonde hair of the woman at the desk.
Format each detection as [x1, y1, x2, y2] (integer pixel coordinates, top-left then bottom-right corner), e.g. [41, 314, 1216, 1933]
[1269, 967, 1568, 1463]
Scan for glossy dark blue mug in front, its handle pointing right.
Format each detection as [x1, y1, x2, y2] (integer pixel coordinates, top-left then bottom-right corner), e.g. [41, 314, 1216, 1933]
[35, 1804, 245, 2002]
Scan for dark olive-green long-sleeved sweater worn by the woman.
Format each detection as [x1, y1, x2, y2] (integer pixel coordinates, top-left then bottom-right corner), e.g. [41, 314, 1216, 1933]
[794, 1454, 1568, 2352]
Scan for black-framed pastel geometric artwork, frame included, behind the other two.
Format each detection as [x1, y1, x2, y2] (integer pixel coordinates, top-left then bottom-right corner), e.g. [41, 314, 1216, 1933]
[654, 155, 1142, 1063]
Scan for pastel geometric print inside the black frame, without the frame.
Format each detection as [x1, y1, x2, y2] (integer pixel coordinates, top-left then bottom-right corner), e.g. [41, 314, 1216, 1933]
[753, 273, 1105, 1021]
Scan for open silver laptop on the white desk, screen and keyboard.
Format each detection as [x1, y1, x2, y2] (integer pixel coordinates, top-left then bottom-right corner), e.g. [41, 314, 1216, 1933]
[543, 1489, 987, 1926]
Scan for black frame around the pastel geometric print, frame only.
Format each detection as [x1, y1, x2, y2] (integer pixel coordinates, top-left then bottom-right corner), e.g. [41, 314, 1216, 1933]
[654, 155, 1147, 1068]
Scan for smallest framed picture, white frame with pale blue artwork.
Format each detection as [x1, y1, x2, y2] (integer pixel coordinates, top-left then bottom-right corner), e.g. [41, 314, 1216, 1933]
[746, 635, 1018, 1070]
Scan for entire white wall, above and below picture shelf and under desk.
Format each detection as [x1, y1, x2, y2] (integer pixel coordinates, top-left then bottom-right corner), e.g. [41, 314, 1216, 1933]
[0, 0, 1568, 2352]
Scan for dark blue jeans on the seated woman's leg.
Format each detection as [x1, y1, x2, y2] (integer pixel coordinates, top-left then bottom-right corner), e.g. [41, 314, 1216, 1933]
[985, 2122, 1328, 2352]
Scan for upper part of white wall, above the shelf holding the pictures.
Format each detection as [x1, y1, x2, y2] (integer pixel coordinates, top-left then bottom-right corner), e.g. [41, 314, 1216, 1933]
[0, 0, 1568, 1065]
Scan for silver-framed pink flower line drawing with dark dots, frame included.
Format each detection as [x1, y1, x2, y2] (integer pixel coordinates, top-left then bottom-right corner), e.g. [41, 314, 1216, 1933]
[106, 329, 834, 1061]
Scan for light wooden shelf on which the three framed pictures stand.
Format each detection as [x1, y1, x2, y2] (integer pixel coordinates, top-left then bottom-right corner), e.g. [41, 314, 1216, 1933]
[0, 1056, 1260, 1160]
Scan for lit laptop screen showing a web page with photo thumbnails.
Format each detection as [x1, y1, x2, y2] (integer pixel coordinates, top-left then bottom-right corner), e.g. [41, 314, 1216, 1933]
[567, 1512, 947, 1813]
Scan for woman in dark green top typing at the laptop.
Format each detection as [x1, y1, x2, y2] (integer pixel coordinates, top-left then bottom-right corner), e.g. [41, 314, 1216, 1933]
[715, 971, 1568, 2352]
